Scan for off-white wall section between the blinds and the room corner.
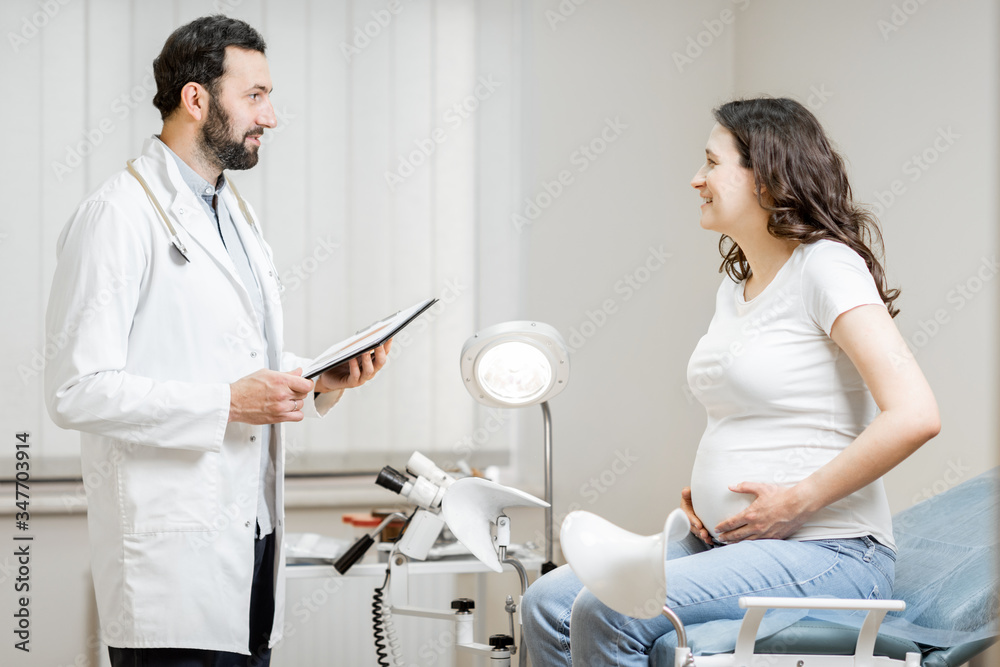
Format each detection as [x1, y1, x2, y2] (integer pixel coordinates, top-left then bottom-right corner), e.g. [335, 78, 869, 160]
[522, 2, 733, 544]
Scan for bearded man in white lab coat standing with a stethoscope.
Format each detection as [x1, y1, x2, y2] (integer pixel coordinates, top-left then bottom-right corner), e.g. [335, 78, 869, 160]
[45, 16, 388, 667]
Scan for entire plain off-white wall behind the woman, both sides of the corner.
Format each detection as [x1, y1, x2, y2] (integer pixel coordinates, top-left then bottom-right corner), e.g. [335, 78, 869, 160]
[524, 0, 1000, 532]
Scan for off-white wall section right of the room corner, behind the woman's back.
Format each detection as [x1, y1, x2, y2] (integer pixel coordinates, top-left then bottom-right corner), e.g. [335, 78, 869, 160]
[736, 0, 1000, 510]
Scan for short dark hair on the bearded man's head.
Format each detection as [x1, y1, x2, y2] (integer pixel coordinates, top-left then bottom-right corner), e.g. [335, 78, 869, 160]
[153, 14, 267, 120]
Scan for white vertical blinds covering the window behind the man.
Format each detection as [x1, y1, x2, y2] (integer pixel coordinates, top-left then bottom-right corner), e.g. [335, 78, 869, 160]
[0, 0, 522, 478]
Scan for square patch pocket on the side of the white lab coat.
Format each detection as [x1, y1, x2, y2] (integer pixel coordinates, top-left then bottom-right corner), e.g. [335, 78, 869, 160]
[118, 447, 220, 534]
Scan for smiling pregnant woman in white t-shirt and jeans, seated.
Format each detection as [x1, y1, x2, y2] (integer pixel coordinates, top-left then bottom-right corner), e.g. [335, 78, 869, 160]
[522, 98, 940, 667]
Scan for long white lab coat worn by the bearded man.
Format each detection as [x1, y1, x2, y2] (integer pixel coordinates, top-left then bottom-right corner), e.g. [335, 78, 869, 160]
[45, 139, 340, 653]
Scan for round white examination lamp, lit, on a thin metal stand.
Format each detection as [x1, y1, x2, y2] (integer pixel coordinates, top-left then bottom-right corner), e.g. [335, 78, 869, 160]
[461, 321, 569, 574]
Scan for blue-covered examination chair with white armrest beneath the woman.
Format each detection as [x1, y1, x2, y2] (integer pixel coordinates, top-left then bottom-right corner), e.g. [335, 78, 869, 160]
[563, 468, 1000, 667]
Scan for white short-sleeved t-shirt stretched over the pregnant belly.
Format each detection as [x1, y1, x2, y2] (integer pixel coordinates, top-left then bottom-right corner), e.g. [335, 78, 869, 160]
[688, 240, 895, 548]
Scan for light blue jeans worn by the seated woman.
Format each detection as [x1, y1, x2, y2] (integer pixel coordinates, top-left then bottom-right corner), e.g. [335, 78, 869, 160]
[521, 535, 896, 667]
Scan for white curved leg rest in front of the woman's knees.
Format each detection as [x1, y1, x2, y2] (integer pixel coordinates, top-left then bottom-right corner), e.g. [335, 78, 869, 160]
[559, 509, 690, 618]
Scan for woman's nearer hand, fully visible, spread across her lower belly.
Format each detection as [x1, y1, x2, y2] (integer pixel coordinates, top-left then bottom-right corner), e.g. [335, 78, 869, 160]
[715, 482, 813, 544]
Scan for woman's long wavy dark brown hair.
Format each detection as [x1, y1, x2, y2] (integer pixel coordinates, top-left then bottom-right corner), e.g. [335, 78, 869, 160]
[712, 98, 899, 317]
